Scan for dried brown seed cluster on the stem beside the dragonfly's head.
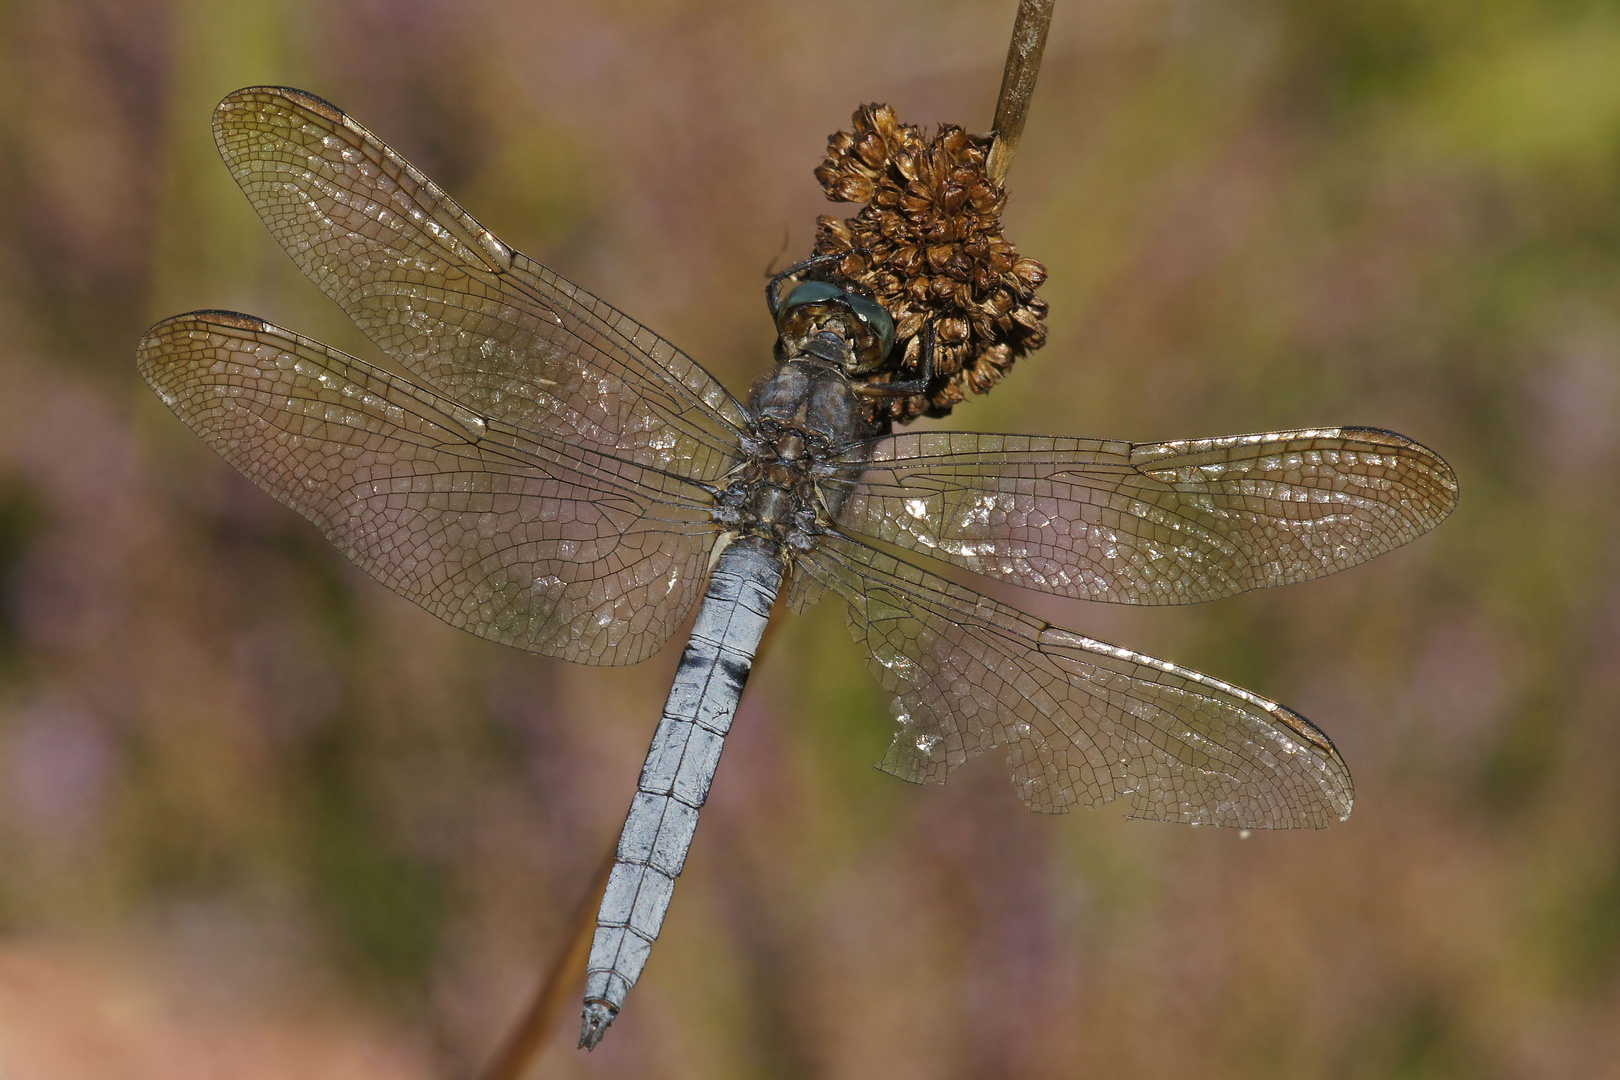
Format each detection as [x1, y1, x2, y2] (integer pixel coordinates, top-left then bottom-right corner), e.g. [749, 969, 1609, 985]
[815, 105, 1047, 423]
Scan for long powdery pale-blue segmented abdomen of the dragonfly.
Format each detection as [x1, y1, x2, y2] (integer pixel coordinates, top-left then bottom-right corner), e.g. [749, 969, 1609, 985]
[580, 538, 782, 1049]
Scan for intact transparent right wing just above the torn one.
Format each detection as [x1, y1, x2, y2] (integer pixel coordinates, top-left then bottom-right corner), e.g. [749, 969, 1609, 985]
[829, 427, 1456, 604]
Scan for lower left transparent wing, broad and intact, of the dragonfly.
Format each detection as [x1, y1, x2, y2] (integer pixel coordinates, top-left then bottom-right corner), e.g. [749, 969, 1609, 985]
[136, 311, 714, 664]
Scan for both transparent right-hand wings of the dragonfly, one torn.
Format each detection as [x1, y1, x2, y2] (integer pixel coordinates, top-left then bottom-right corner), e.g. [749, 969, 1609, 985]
[804, 427, 1456, 827]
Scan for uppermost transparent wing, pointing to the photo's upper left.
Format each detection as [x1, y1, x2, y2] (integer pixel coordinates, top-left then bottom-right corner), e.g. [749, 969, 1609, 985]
[214, 87, 747, 481]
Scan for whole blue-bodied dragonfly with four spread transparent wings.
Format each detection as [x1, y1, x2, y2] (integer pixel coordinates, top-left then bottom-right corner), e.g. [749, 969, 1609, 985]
[138, 87, 1456, 1048]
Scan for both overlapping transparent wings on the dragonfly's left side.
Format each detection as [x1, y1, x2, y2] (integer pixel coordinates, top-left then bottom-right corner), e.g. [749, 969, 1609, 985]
[139, 87, 747, 664]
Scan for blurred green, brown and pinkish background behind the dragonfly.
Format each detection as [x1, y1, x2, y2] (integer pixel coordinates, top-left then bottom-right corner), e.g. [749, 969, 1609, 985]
[0, 0, 1620, 1080]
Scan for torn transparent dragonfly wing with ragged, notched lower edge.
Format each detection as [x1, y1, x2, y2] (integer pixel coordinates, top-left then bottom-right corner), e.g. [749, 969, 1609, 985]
[795, 536, 1354, 829]
